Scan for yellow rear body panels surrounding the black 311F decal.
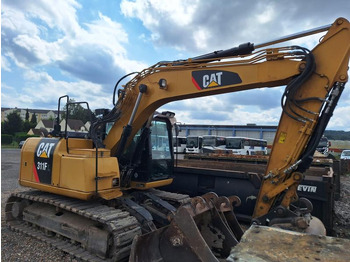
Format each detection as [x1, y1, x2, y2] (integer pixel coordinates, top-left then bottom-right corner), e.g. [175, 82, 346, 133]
[20, 138, 122, 200]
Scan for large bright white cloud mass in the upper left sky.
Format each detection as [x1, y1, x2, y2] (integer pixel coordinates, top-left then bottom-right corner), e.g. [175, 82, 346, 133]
[2, 0, 145, 86]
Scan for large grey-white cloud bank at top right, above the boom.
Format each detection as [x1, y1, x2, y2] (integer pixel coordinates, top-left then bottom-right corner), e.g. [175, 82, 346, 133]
[120, 0, 350, 54]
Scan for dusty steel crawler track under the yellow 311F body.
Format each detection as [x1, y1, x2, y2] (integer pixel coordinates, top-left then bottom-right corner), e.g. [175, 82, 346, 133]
[5, 191, 141, 261]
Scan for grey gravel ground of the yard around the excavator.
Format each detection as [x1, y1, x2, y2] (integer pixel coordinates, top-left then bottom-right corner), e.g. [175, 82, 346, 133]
[1, 149, 350, 262]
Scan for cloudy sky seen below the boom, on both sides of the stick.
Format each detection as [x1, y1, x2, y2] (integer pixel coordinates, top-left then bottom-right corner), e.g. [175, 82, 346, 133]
[163, 87, 350, 131]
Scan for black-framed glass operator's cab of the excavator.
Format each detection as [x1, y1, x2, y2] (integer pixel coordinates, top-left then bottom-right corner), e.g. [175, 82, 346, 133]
[120, 115, 174, 189]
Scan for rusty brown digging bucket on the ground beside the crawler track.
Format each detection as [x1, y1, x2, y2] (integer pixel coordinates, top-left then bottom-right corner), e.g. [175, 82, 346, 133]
[129, 193, 243, 262]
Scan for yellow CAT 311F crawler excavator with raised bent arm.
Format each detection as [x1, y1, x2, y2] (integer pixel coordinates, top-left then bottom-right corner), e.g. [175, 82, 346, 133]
[5, 18, 350, 261]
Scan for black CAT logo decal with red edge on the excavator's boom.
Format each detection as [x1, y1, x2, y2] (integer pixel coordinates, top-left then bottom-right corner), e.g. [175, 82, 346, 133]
[192, 70, 242, 90]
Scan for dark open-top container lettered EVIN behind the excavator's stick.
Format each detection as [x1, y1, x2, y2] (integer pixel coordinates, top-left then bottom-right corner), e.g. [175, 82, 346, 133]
[165, 154, 339, 235]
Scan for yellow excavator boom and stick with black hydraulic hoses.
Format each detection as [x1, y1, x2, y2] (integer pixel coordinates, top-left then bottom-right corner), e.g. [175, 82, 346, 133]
[100, 18, 350, 224]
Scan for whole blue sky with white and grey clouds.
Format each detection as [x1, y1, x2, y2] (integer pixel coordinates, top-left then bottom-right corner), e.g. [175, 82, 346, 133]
[1, 0, 350, 131]
